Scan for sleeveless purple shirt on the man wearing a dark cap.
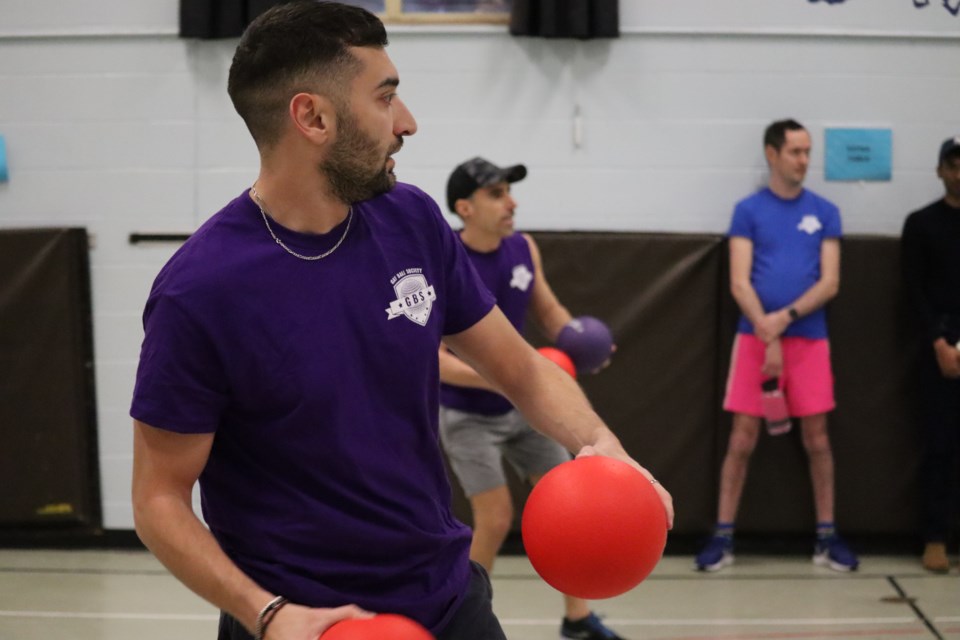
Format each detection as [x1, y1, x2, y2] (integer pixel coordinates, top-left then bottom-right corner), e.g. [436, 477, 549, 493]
[440, 233, 535, 416]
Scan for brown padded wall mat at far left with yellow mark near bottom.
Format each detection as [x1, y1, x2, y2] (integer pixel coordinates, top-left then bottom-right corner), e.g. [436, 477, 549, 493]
[0, 229, 100, 528]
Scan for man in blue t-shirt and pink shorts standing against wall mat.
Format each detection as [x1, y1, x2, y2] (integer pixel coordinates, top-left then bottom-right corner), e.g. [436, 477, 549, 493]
[696, 120, 858, 571]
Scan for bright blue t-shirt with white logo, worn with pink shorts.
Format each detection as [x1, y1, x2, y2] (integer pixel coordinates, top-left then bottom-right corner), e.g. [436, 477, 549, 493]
[729, 188, 841, 338]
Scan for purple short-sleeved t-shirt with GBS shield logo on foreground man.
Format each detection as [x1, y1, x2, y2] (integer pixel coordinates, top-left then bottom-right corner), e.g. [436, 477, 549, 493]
[131, 184, 494, 630]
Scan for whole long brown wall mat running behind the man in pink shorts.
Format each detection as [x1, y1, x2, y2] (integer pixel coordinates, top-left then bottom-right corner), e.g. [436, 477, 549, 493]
[446, 232, 919, 534]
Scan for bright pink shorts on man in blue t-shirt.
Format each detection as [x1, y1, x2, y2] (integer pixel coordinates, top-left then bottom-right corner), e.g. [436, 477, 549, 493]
[723, 333, 836, 418]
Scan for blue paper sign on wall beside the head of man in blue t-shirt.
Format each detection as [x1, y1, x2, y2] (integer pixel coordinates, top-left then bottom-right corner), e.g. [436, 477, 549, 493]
[825, 129, 893, 181]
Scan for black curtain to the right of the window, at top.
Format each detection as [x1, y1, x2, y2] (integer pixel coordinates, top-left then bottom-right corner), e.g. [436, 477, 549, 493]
[510, 0, 620, 40]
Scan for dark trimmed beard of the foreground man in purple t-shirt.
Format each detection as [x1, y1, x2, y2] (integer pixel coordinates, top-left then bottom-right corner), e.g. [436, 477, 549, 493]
[320, 109, 403, 204]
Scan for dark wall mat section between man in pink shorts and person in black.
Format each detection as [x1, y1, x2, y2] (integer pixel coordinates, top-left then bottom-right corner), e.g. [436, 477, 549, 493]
[830, 236, 920, 533]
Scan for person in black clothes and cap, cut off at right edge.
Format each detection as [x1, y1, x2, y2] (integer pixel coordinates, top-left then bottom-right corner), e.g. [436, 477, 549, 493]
[901, 136, 960, 573]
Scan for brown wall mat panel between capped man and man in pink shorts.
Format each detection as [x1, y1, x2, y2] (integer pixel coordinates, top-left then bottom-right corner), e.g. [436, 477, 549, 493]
[535, 233, 721, 531]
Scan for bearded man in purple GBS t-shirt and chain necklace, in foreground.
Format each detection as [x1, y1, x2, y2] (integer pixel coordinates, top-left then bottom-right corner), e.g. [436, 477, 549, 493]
[131, 0, 672, 640]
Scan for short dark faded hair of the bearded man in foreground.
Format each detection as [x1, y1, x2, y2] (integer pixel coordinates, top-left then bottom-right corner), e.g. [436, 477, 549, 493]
[227, 0, 387, 148]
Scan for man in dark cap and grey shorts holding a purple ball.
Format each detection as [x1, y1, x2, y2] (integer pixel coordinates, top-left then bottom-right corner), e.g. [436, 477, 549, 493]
[439, 157, 622, 640]
